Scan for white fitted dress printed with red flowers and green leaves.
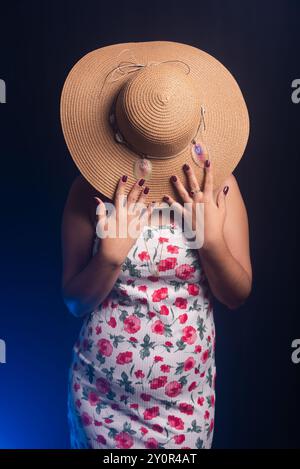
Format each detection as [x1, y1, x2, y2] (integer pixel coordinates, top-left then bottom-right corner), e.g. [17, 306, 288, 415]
[68, 223, 216, 449]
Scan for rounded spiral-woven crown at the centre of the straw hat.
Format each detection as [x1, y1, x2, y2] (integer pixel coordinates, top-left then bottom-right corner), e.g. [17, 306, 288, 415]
[116, 63, 200, 158]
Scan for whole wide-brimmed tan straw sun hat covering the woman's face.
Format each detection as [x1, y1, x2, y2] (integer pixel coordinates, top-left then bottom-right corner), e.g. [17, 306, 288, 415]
[61, 41, 249, 201]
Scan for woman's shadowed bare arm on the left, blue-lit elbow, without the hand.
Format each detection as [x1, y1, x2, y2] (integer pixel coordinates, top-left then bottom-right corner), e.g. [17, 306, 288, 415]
[61, 176, 120, 317]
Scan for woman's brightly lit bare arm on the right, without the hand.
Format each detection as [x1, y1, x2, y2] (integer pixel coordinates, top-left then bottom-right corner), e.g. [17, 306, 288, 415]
[198, 174, 252, 309]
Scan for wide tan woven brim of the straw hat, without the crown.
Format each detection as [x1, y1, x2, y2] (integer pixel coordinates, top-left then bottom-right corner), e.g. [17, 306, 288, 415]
[60, 41, 249, 201]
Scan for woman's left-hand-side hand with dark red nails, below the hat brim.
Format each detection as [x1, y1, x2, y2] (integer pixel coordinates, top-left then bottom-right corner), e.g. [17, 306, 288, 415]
[95, 176, 154, 267]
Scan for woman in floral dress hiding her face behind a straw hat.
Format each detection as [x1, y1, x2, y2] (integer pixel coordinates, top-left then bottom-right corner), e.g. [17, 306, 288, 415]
[61, 41, 252, 449]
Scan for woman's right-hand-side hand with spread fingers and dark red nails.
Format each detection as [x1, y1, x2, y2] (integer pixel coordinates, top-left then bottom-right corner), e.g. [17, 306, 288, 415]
[163, 160, 228, 250]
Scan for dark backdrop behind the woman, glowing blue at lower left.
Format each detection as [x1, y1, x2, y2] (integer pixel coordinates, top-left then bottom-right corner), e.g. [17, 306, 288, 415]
[0, 0, 300, 448]
